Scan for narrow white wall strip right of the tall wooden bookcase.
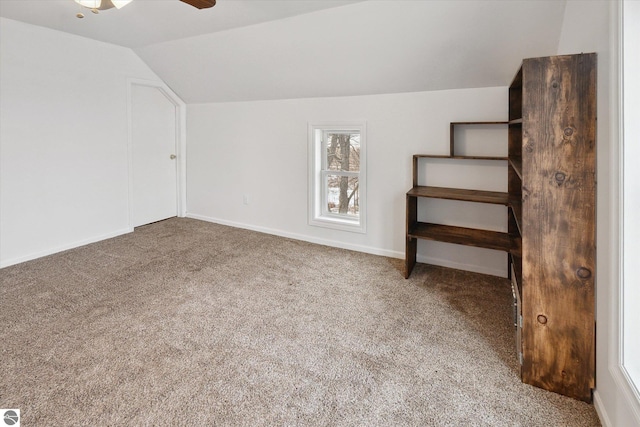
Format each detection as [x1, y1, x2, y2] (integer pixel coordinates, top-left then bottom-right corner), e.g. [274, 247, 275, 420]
[558, 1, 640, 427]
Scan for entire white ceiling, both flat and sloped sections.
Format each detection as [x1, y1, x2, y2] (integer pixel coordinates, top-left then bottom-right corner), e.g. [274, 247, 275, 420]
[0, 0, 565, 103]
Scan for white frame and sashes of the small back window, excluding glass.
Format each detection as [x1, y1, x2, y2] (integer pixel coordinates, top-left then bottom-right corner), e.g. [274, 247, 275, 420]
[308, 122, 367, 233]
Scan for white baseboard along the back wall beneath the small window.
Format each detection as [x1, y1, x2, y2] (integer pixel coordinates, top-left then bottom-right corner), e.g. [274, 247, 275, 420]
[186, 213, 506, 277]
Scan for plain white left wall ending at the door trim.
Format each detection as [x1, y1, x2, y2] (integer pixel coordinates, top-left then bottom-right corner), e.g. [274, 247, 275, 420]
[0, 18, 165, 266]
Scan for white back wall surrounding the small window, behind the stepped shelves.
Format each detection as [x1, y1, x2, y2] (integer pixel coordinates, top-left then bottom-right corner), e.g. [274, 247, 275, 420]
[187, 88, 516, 276]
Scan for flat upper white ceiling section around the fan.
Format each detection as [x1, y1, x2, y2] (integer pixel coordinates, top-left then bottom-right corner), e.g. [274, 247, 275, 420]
[0, 0, 362, 48]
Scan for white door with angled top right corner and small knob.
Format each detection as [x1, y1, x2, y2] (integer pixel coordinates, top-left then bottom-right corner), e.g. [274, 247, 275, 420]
[131, 84, 178, 227]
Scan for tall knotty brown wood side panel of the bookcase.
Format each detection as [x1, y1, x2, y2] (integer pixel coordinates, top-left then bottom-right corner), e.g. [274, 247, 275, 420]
[521, 54, 596, 401]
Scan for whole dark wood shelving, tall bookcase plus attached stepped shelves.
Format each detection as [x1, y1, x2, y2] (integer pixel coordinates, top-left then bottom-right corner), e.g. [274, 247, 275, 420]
[405, 53, 597, 402]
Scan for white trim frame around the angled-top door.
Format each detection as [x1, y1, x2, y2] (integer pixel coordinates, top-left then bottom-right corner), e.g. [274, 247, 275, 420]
[127, 78, 187, 230]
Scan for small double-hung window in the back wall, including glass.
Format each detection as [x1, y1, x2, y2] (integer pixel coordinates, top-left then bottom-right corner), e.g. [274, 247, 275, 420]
[309, 123, 366, 233]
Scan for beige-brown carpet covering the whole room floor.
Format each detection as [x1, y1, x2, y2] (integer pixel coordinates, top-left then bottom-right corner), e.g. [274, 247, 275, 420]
[0, 219, 599, 426]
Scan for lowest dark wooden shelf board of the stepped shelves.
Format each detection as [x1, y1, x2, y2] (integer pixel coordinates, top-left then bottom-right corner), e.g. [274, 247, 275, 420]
[407, 222, 511, 252]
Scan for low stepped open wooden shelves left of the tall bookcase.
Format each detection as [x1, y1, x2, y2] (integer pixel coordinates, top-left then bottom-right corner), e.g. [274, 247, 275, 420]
[405, 121, 510, 278]
